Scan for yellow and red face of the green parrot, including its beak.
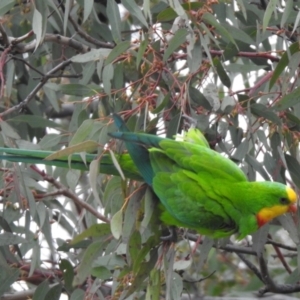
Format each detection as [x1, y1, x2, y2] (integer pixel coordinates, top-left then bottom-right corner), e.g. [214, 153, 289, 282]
[256, 184, 297, 227]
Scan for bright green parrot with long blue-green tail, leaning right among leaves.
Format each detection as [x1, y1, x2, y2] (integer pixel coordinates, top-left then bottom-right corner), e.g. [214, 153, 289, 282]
[0, 115, 297, 239]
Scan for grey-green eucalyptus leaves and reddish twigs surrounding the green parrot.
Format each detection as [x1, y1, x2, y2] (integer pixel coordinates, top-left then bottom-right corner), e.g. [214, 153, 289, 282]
[0, 0, 300, 299]
